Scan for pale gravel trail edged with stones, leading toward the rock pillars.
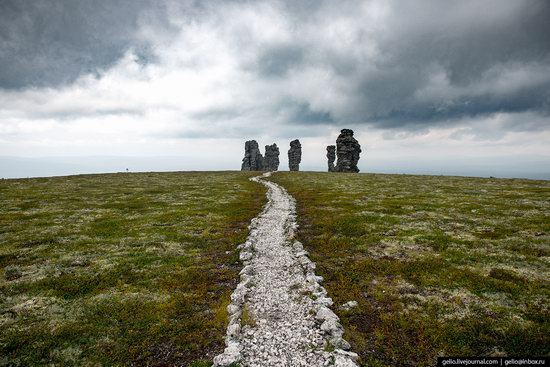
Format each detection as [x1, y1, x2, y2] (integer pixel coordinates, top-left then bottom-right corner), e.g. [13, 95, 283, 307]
[214, 173, 357, 367]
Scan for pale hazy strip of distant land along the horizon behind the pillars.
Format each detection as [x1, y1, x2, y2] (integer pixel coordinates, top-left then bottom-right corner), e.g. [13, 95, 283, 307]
[0, 155, 550, 180]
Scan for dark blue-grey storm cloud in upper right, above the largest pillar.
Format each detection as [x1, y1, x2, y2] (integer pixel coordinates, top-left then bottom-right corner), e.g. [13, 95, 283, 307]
[350, 1, 550, 126]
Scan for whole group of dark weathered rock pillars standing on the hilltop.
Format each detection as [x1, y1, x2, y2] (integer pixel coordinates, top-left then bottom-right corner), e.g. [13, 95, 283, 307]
[241, 129, 361, 173]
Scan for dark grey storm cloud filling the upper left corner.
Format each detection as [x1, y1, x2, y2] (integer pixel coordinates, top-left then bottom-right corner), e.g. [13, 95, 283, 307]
[0, 0, 171, 88]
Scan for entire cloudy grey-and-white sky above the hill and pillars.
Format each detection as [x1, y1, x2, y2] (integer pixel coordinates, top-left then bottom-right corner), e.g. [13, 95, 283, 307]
[0, 0, 550, 179]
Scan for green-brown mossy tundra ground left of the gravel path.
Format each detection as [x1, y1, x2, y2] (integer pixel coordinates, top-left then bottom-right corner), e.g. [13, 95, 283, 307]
[0, 172, 266, 366]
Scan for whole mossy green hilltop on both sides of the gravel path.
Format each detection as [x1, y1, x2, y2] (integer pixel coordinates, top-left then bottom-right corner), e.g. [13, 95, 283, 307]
[0, 172, 550, 366]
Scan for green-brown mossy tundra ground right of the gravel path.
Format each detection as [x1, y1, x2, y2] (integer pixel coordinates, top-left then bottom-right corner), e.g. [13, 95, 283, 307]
[272, 172, 550, 366]
